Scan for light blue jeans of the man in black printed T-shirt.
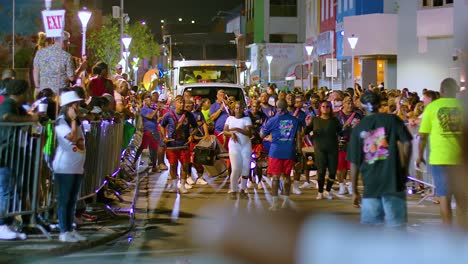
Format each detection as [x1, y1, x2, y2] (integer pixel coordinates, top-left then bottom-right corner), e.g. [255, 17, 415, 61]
[361, 191, 408, 227]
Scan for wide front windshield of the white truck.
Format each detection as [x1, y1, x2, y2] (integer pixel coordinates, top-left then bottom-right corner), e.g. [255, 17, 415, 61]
[179, 66, 237, 85]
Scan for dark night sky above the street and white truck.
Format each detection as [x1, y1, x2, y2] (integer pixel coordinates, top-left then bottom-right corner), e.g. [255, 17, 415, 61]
[103, 0, 244, 38]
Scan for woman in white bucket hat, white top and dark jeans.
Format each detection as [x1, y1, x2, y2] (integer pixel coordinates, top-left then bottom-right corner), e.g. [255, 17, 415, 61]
[52, 91, 86, 242]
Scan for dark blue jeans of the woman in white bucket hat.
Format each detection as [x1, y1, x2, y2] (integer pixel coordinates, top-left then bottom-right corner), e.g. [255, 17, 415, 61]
[54, 173, 83, 233]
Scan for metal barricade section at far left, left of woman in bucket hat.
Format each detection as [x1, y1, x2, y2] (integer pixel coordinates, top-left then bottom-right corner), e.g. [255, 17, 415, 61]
[0, 123, 53, 238]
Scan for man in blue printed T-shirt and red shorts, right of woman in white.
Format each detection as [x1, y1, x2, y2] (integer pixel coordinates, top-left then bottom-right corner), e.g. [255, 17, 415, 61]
[260, 99, 301, 211]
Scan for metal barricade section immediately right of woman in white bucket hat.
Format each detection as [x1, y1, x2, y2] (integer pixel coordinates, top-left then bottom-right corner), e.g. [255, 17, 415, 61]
[80, 121, 124, 200]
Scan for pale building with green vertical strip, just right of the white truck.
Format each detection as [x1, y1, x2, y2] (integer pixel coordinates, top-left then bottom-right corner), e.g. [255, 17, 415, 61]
[245, 0, 306, 86]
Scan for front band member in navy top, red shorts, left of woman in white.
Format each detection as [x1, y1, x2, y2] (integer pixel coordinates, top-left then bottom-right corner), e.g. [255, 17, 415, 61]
[160, 95, 198, 193]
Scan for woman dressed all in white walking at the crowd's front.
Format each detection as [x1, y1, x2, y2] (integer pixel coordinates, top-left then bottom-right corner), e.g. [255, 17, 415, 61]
[224, 101, 252, 199]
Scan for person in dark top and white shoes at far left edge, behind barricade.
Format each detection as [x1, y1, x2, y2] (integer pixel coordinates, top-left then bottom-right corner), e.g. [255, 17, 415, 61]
[0, 80, 39, 240]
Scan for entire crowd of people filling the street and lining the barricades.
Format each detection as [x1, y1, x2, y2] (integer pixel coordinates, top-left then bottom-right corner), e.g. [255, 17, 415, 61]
[0, 28, 466, 245]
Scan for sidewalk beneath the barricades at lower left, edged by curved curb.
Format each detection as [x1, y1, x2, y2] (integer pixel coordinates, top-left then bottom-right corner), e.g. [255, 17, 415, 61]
[0, 191, 134, 263]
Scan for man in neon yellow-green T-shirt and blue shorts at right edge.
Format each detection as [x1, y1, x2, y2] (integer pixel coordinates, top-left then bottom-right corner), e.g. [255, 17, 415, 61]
[416, 78, 467, 228]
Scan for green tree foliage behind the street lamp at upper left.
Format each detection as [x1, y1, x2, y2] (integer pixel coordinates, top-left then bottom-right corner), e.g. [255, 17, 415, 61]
[87, 17, 159, 69]
